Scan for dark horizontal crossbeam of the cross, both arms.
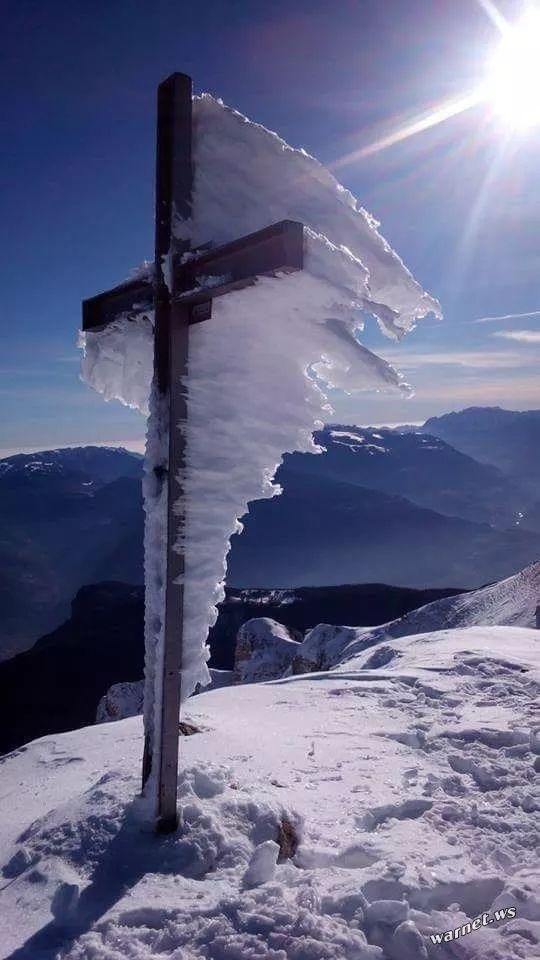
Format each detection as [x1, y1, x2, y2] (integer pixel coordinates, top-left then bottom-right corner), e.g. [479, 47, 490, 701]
[82, 220, 304, 330]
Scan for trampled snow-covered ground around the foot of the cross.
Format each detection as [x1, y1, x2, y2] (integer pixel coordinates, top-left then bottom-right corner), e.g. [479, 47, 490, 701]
[0, 626, 540, 960]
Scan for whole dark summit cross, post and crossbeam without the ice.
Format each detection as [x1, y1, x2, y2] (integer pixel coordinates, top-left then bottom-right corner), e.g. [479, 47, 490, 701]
[82, 73, 303, 832]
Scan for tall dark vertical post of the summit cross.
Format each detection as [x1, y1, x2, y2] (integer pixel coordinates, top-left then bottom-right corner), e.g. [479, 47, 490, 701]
[143, 73, 193, 833]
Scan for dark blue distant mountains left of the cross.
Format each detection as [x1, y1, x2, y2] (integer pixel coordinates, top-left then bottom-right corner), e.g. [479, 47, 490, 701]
[0, 447, 143, 660]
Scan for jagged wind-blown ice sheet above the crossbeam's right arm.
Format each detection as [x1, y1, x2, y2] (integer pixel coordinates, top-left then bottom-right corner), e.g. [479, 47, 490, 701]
[184, 94, 439, 336]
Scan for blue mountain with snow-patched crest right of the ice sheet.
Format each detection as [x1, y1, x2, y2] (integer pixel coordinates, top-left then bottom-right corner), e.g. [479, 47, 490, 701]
[228, 411, 540, 587]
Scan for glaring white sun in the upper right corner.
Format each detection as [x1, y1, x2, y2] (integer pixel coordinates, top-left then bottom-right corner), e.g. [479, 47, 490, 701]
[485, 9, 540, 129]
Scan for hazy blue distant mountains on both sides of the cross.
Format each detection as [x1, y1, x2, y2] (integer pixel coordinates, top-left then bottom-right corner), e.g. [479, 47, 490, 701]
[0, 408, 540, 660]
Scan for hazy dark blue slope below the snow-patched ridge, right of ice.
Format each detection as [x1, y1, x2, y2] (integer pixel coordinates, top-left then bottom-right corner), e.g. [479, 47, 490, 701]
[228, 467, 540, 587]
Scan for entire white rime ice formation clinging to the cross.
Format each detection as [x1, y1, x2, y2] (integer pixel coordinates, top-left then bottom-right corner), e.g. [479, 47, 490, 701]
[82, 94, 440, 713]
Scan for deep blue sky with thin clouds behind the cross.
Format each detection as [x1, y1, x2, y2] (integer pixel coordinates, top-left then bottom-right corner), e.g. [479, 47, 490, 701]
[0, 0, 540, 455]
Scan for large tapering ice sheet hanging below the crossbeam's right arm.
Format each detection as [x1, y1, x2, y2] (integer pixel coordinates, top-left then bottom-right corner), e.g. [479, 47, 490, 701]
[179, 273, 412, 698]
